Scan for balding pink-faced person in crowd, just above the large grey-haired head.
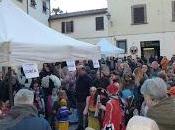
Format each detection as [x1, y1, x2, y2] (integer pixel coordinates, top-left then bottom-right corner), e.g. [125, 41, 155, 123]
[150, 61, 161, 78]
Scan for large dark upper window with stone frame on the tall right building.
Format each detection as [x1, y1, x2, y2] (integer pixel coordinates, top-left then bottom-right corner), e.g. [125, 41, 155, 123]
[131, 5, 147, 24]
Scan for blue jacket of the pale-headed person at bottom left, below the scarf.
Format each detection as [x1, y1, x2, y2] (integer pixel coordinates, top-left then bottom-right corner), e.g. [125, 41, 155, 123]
[7, 117, 51, 130]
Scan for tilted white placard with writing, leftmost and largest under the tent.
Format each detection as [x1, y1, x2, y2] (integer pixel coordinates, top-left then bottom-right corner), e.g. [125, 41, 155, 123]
[22, 64, 39, 79]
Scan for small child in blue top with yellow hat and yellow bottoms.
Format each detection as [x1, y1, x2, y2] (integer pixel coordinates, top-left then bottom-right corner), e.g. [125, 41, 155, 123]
[56, 99, 70, 130]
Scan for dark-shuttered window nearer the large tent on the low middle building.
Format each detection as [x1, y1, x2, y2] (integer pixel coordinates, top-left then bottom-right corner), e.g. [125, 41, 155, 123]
[61, 21, 74, 33]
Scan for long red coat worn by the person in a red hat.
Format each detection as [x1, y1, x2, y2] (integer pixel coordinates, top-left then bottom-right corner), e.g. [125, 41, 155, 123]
[103, 99, 125, 130]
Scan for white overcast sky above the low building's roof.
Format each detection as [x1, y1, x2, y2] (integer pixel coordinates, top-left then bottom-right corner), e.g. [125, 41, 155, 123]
[51, 0, 107, 12]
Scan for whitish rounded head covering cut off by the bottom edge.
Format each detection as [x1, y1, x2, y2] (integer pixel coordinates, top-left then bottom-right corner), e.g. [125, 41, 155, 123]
[126, 116, 159, 130]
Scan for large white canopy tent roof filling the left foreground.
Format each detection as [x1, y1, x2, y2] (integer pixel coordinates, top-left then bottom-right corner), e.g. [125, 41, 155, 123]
[0, 0, 100, 66]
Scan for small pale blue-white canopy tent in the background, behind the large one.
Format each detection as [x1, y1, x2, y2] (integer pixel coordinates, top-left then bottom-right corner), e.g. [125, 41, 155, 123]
[97, 38, 124, 56]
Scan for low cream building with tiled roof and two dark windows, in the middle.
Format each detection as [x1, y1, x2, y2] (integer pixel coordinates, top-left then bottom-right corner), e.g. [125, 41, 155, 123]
[49, 8, 108, 44]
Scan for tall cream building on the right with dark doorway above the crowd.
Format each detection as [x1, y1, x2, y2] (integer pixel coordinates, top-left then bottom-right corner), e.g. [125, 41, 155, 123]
[108, 0, 175, 58]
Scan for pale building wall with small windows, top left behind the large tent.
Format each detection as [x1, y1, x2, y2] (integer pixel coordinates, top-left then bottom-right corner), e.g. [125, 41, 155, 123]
[12, 0, 50, 26]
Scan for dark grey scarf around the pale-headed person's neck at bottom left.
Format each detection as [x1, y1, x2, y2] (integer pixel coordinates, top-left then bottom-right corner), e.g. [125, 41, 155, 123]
[0, 105, 38, 130]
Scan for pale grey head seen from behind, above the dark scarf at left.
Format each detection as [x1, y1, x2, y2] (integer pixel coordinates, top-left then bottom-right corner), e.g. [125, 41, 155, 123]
[14, 89, 34, 105]
